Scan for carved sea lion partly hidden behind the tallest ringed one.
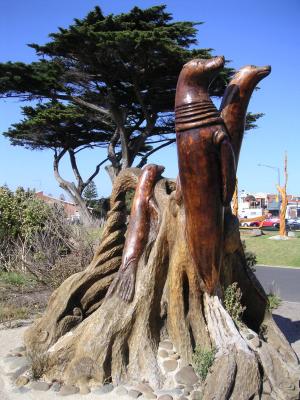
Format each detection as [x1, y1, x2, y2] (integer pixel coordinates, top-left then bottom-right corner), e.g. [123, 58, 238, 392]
[220, 65, 271, 167]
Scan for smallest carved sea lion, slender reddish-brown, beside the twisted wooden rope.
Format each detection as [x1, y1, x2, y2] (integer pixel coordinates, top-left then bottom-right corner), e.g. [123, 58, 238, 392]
[107, 164, 164, 302]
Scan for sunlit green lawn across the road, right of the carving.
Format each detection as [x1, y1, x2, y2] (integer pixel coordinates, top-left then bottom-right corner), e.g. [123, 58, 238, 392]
[241, 231, 300, 268]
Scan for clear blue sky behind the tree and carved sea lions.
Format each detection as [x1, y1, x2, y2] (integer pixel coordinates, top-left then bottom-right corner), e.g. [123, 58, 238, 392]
[0, 0, 300, 196]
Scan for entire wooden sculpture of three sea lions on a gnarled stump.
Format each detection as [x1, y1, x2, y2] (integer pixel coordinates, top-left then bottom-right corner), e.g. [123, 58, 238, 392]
[21, 57, 300, 400]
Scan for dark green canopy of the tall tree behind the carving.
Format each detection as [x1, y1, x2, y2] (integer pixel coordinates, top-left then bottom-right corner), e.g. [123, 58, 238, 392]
[0, 5, 258, 183]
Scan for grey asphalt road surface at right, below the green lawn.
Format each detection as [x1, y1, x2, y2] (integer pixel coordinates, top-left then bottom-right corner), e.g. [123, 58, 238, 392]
[255, 265, 300, 303]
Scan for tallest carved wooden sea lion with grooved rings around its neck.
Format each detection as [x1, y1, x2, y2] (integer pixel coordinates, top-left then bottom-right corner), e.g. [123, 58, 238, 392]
[175, 57, 235, 294]
